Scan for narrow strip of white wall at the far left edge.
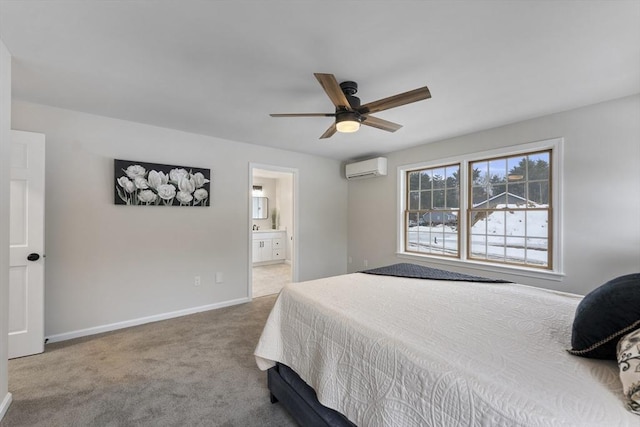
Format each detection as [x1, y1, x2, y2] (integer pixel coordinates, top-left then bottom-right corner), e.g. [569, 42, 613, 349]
[0, 40, 11, 419]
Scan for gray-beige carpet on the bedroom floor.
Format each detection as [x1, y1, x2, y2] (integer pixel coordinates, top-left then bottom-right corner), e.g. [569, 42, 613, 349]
[0, 296, 296, 427]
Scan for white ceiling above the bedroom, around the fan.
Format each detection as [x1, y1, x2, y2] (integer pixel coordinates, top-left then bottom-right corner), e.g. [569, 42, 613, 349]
[0, 0, 640, 160]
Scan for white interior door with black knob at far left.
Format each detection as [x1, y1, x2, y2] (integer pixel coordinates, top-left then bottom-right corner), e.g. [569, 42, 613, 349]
[8, 130, 44, 359]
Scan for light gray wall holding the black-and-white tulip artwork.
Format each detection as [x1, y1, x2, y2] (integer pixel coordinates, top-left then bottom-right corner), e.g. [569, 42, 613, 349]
[12, 102, 347, 337]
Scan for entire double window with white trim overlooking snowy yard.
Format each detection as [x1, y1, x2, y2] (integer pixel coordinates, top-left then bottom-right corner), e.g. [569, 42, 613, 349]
[398, 139, 562, 272]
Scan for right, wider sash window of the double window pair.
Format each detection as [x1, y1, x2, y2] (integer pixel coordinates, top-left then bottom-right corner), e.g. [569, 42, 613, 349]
[467, 150, 552, 268]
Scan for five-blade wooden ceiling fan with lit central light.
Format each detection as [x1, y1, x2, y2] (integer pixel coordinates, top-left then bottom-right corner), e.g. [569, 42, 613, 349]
[270, 73, 431, 139]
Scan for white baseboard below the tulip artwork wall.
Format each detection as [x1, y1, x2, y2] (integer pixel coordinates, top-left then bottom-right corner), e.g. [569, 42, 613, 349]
[45, 298, 251, 343]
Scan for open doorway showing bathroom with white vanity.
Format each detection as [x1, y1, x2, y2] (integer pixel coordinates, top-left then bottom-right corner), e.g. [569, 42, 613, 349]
[249, 163, 298, 298]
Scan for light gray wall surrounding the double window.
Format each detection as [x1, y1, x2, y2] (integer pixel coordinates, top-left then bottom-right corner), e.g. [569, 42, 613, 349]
[348, 95, 640, 294]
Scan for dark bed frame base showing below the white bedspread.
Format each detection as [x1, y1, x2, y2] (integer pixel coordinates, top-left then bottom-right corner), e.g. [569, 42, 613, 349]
[267, 363, 356, 427]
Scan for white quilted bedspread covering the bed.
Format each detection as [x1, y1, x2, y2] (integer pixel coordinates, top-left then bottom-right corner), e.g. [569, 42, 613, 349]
[255, 273, 640, 427]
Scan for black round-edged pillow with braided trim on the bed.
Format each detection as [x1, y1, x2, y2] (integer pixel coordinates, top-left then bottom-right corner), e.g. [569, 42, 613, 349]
[567, 273, 640, 360]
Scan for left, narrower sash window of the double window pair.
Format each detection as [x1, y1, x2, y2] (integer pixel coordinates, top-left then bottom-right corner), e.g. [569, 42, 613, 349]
[405, 164, 460, 257]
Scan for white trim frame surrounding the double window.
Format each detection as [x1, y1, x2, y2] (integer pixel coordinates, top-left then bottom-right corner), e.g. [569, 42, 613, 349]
[396, 138, 564, 281]
